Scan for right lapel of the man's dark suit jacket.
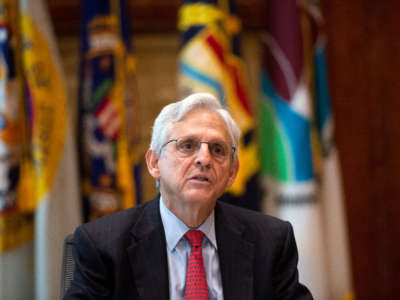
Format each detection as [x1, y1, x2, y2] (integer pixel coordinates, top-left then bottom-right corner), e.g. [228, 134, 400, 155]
[215, 201, 254, 300]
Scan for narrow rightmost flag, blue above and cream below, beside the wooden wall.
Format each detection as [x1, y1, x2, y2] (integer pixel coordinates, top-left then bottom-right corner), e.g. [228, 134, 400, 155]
[304, 2, 354, 300]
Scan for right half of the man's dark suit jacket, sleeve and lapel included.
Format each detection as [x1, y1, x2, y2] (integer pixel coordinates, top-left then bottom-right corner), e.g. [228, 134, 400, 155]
[215, 202, 312, 300]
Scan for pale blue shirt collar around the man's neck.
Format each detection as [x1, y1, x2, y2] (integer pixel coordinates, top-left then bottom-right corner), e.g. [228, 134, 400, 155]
[160, 197, 217, 251]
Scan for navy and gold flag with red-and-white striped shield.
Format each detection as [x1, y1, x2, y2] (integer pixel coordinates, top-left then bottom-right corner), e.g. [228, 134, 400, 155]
[79, 0, 141, 220]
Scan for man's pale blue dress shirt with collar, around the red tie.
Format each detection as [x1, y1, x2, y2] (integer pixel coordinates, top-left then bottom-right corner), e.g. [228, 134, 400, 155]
[159, 197, 223, 300]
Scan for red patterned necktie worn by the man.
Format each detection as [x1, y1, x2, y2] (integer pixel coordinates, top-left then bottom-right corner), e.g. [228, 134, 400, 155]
[185, 230, 210, 300]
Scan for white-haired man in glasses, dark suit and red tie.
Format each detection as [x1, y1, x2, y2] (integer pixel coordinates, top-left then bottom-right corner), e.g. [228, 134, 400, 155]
[65, 94, 312, 300]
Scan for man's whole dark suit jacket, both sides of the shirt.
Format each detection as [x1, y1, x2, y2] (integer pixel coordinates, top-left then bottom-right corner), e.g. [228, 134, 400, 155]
[64, 197, 312, 300]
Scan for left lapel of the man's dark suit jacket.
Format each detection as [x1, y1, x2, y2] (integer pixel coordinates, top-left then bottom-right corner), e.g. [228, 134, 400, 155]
[127, 198, 169, 300]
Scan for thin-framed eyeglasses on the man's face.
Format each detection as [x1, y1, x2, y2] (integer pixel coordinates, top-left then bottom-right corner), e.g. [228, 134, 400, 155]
[161, 136, 236, 162]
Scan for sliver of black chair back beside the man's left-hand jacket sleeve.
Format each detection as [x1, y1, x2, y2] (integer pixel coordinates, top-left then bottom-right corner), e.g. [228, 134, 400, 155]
[60, 234, 75, 300]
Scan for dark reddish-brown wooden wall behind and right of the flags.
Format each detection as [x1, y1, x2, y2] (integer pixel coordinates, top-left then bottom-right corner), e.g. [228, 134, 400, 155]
[47, 0, 400, 300]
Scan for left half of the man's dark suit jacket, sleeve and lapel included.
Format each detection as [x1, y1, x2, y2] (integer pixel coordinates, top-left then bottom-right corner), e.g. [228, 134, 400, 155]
[64, 197, 168, 300]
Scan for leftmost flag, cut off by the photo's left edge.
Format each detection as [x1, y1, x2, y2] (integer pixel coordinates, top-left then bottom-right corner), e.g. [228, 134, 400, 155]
[0, 0, 34, 300]
